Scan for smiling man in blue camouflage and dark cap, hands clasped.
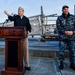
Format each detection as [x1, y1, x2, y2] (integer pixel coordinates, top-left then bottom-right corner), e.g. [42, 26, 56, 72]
[56, 5, 75, 70]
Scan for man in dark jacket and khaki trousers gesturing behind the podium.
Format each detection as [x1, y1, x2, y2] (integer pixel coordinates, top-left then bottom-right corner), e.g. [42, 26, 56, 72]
[4, 7, 31, 71]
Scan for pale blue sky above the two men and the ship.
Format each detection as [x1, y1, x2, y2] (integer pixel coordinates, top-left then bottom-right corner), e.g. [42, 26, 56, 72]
[0, 0, 75, 22]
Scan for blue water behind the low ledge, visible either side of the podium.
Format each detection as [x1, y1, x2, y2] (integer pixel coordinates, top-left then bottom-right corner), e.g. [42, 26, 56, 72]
[0, 36, 59, 48]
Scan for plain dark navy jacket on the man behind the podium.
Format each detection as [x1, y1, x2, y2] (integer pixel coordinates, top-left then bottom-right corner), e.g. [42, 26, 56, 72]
[8, 15, 31, 32]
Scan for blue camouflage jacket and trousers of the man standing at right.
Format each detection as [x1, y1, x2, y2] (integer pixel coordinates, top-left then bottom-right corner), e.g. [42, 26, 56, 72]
[56, 14, 75, 62]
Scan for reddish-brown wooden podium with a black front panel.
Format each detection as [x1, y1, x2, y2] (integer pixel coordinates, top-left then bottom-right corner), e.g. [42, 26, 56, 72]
[0, 27, 26, 75]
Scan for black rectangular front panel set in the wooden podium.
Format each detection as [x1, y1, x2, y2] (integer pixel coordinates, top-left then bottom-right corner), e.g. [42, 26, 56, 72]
[8, 41, 18, 68]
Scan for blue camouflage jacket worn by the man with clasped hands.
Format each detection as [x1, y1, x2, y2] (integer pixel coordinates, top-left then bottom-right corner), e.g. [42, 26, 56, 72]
[56, 14, 75, 40]
